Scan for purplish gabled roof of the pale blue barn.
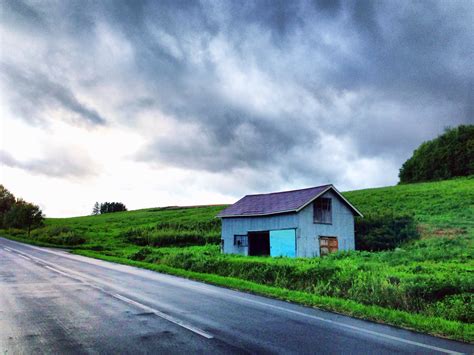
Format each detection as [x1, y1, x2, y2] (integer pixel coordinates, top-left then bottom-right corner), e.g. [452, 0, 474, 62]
[217, 185, 362, 218]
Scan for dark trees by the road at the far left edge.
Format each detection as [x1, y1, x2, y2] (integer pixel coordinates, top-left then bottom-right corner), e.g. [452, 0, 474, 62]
[0, 185, 44, 237]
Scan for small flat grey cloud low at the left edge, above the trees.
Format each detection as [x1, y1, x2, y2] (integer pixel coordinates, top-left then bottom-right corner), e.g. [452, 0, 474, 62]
[0, 151, 96, 178]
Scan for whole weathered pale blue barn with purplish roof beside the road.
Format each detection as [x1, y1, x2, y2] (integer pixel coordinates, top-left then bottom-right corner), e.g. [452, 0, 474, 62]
[218, 185, 362, 257]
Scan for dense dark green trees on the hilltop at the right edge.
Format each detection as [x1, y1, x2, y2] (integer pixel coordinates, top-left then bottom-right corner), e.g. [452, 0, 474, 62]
[399, 125, 474, 183]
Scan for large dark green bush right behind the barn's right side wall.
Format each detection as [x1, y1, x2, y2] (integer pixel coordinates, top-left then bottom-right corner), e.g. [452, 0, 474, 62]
[355, 214, 419, 251]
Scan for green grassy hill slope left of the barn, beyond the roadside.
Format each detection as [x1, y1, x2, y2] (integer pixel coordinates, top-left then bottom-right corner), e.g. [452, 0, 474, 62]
[42, 205, 225, 249]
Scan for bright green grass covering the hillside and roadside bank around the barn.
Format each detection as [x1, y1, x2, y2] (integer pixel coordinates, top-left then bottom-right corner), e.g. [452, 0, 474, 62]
[1, 178, 474, 342]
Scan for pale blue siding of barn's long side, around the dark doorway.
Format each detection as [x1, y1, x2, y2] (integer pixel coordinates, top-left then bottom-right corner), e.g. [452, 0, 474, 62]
[222, 213, 298, 255]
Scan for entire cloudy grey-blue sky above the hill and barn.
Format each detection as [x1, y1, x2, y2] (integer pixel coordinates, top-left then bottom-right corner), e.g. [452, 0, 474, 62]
[0, 0, 474, 217]
